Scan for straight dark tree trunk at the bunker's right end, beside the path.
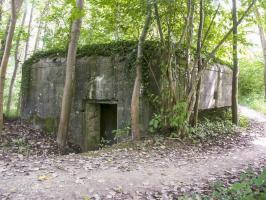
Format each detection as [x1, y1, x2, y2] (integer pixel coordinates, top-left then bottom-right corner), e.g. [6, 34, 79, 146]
[232, 0, 239, 125]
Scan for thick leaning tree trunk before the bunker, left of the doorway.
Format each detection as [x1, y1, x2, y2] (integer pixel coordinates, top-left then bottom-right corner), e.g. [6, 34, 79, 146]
[57, 0, 83, 152]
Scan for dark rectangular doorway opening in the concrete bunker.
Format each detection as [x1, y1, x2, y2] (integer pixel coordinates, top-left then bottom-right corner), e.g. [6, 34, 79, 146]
[100, 104, 117, 145]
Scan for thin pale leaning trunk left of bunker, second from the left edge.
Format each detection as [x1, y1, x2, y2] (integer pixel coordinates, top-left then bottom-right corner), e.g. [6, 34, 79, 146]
[6, 8, 27, 115]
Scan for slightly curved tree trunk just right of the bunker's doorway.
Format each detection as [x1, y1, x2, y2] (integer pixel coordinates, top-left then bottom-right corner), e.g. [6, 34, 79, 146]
[131, 0, 151, 140]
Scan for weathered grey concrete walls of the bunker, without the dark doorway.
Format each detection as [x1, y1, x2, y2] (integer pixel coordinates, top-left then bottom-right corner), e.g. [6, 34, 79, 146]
[22, 52, 232, 150]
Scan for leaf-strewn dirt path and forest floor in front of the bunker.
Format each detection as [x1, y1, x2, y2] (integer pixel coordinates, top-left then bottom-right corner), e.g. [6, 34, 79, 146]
[0, 107, 266, 200]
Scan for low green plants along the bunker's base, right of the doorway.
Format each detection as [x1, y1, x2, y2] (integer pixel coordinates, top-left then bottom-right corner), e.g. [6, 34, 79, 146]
[149, 108, 238, 143]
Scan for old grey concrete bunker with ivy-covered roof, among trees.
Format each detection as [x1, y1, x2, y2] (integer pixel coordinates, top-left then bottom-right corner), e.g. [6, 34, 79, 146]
[21, 42, 232, 151]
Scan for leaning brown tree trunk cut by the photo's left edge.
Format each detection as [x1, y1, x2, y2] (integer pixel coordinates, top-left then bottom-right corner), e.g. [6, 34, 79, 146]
[0, 0, 23, 132]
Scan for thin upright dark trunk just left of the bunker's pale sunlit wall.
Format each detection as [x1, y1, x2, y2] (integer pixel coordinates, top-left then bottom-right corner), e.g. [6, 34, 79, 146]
[193, 0, 205, 126]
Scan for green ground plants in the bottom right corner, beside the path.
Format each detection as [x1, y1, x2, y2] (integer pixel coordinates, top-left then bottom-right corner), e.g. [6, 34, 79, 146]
[180, 169, 266, 200]
